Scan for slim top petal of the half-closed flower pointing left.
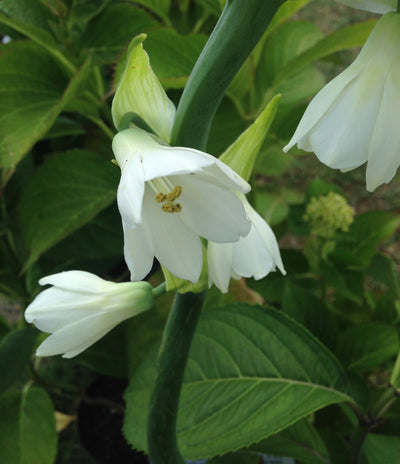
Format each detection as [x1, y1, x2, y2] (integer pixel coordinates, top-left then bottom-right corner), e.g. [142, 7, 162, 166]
[39, 271, 110, 293]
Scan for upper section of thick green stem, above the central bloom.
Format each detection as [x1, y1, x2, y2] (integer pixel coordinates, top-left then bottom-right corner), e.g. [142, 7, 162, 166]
[172, 0, 282, 150]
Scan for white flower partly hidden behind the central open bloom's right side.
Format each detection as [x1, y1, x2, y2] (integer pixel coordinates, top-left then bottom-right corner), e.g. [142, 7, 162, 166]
[207, 195, 286, 293]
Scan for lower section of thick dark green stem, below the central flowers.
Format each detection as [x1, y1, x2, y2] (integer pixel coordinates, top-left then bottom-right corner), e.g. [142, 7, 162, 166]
[147, 293, 204, 464]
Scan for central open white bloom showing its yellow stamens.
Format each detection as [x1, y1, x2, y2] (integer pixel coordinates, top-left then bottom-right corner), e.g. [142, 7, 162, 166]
[113, 129, 250, 282]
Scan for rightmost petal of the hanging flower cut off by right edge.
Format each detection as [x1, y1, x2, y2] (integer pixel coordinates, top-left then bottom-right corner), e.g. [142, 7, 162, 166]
[367, 69, 400, 192]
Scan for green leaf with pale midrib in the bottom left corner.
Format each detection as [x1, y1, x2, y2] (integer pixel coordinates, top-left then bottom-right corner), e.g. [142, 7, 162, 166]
[0, 387, 57, 464]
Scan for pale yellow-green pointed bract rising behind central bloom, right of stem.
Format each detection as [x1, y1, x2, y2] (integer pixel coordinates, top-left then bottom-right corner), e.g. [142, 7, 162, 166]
[220, 95, 280, 181]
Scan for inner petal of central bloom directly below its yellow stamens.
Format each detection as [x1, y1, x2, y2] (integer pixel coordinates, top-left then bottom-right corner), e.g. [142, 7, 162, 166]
[143, 189, 203, 283]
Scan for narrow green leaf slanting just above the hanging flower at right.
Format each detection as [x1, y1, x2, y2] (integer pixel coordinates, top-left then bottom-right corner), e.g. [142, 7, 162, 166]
[275, 19, 376, 81]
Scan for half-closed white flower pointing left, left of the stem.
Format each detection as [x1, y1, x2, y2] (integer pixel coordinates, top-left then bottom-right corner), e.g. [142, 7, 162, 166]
[25, 271, 153, 358]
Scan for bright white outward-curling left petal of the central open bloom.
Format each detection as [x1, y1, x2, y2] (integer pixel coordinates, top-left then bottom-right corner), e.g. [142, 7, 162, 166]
[117, 152, 145, 228]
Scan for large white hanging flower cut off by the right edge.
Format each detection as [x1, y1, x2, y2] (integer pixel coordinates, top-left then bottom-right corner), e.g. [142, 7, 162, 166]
[284, 13, 400, 191]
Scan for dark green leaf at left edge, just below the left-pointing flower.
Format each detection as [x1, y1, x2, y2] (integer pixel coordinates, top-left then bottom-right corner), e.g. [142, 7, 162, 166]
[0, 329, 38, 395]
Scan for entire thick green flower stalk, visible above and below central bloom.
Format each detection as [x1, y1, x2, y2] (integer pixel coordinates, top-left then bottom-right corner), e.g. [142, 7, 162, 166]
[147, 0, 282, 464]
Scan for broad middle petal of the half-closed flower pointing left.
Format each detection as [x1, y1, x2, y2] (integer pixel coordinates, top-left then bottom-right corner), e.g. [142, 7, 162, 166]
[25, 287, 104, 332]
